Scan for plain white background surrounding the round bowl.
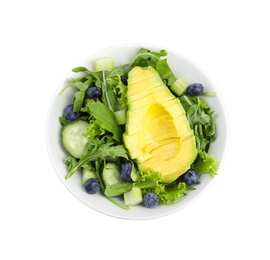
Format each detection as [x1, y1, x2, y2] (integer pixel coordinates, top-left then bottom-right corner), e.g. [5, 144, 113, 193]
[0, 0, 270, 260]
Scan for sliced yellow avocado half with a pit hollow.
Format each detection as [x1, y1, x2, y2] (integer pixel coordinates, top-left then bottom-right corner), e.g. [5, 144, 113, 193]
[123, 67, 197, 183]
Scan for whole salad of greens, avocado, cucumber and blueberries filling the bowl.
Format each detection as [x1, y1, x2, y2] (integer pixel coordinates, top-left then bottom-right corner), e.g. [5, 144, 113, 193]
[59, 48, 219, 209]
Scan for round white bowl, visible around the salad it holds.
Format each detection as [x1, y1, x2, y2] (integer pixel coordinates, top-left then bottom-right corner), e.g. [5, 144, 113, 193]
[46, 44, 228, 220]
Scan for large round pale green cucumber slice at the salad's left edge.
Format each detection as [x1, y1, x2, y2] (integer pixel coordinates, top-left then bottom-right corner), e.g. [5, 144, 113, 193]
[62, 120, 89, 158]
